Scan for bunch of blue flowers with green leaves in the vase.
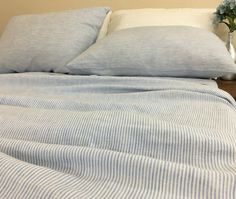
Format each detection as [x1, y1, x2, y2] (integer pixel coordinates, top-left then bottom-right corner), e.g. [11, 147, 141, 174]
[214, 0, 236, 32]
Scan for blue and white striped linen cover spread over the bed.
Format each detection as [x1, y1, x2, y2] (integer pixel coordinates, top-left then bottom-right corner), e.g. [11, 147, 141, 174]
[0, 73, 236, 199]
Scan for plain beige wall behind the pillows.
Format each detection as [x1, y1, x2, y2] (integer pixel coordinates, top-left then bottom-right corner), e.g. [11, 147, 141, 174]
[0, 0, 220, 33]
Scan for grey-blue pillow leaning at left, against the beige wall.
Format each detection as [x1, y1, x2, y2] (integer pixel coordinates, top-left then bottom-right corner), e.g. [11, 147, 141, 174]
[0, 8, 109, 73]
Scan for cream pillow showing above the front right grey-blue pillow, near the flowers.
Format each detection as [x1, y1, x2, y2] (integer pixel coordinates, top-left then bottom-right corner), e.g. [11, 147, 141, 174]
[108, 8, 215, 34]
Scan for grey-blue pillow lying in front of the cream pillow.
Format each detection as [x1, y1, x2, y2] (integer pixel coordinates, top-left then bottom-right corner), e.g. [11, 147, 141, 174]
[67, 26, 236, 78]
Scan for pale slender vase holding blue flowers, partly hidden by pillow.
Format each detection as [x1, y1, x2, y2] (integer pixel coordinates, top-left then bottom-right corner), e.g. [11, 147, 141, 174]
[221, 32, 236, 81]
